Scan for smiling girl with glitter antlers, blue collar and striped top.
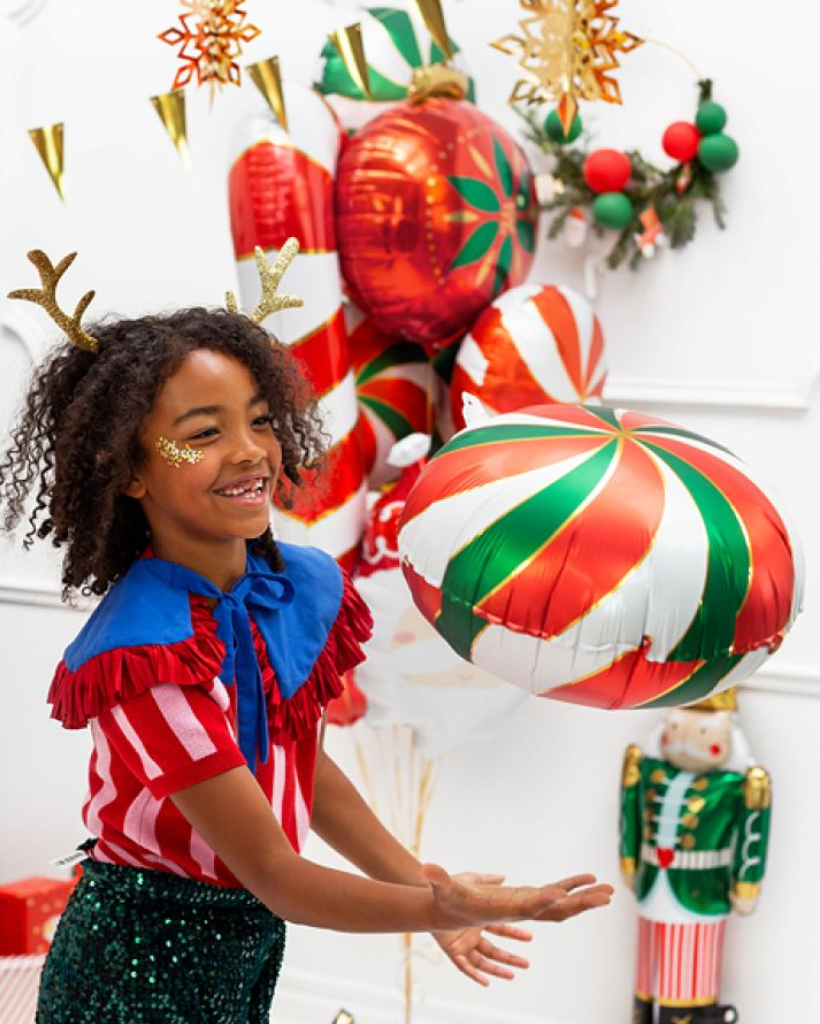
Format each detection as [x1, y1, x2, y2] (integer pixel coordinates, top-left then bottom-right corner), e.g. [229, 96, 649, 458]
[0, 245, 611, 1024]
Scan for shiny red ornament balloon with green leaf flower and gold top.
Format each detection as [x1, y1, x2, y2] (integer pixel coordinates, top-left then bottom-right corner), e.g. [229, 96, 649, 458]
[336, 97, 538, 352]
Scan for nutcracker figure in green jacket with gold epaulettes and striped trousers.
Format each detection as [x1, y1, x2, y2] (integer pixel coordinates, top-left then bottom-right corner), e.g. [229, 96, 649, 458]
[620, 690, 772, 1024]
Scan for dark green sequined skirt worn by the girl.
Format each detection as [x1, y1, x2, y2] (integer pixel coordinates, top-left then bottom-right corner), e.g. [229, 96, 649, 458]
[36, 860, 285, 1024]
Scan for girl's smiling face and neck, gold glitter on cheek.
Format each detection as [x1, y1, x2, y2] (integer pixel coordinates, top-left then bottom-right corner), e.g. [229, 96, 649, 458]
[127, 348, 282, 587]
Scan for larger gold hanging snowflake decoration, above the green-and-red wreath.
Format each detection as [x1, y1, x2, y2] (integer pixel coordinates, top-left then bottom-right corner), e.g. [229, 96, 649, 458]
[490, 0, 643, 132]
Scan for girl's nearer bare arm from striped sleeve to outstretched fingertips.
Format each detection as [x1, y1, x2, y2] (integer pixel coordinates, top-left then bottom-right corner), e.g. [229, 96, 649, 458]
[172, 768, 611, 932]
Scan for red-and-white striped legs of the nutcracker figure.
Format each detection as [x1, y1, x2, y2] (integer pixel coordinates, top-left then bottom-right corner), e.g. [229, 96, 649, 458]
[635, 918, 726, 1007]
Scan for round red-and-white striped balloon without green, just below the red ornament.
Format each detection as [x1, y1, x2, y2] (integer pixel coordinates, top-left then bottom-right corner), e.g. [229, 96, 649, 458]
[450, 283, 606, 429]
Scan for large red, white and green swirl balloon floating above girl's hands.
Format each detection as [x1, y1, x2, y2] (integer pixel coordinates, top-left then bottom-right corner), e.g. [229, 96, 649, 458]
[399, 406, 804, 708]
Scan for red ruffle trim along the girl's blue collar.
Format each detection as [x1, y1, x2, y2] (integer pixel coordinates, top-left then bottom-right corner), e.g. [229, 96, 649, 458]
[48, 574, 373, 743]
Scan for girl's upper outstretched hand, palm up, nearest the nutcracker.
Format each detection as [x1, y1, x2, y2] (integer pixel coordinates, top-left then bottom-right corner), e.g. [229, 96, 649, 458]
[424, 864, 613, 932]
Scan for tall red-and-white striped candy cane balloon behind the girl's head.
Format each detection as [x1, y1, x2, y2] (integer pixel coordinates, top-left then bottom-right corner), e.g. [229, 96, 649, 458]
[229, 83, 366, 567]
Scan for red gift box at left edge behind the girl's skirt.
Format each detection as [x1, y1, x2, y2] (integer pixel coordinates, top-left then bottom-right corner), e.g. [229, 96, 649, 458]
[0, 877, 77, 956]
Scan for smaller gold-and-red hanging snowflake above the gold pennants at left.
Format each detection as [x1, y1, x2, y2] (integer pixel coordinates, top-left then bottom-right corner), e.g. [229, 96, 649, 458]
[159, 0, 261, 96]
